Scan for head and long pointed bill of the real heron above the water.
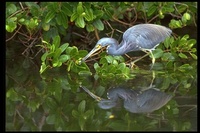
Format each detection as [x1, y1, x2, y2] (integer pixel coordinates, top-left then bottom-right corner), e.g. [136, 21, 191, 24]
[81, 37, 118, 62]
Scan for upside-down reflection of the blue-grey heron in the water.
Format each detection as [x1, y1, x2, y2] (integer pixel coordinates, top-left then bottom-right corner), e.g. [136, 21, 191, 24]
[81, 86, 172, 113]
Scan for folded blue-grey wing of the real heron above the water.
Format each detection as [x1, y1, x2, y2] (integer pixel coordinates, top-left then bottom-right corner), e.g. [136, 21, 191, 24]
[123, 24, 172, 51]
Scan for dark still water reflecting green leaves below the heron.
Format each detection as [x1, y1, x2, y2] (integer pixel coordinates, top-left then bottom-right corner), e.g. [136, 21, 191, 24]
[6, 59, 197, 131]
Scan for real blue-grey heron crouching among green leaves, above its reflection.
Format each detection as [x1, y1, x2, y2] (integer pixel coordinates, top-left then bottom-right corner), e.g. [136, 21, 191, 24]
[81, 24, 172, 66]
